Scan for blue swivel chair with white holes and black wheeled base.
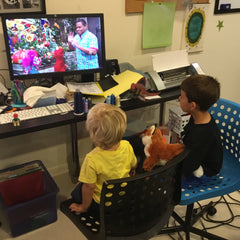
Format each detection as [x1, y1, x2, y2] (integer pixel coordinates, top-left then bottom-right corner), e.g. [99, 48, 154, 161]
[161, 99, 240, 240]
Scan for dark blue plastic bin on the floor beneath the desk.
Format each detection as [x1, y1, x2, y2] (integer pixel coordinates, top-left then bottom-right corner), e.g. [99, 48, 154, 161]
[0, 160, 59, 237]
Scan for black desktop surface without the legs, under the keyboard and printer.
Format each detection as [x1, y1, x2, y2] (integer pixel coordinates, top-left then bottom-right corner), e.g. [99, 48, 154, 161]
[0, 88, 180, 139]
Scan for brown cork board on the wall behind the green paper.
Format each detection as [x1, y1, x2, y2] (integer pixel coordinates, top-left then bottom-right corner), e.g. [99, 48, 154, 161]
[125, 0, 209, 13]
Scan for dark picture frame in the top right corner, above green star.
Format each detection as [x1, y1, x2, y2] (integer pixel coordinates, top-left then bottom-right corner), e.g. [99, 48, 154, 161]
[214, 0, 240, 14]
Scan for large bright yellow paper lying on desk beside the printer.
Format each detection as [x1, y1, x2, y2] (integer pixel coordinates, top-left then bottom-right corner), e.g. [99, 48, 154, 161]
[104, 70, 143, 98]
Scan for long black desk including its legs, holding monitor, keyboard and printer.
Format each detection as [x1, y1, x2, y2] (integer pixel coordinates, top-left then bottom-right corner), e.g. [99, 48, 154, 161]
[0, 88, 180, 182]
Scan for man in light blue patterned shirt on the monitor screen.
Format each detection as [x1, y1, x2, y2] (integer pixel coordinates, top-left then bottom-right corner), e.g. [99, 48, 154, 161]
[68, 19, 99, 70]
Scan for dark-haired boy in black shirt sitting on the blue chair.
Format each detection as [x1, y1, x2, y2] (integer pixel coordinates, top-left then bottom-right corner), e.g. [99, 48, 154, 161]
[179, 75, 223, 177]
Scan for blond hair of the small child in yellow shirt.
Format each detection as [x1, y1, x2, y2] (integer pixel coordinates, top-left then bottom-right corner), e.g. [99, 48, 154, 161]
[86, 103, 127, 149]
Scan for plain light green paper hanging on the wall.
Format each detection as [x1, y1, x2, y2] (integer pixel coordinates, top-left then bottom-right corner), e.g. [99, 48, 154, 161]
[142, 2, 176, 48]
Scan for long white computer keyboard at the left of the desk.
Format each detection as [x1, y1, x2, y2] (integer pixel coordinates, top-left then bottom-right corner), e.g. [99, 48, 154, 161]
[0, 103, 73, 124]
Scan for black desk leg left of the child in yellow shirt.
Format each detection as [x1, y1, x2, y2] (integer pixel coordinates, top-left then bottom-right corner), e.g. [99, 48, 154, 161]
[68, 123, 80, 183]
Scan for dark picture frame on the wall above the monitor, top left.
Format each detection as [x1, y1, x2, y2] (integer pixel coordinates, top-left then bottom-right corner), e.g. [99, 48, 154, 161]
[0, 0, 46, 15]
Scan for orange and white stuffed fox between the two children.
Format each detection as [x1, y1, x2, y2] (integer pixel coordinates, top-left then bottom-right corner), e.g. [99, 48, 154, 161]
[142, 126, 184, 171]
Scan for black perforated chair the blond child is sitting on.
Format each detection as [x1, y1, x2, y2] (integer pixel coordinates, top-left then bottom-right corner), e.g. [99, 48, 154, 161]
[60, 150, 187, 240]
